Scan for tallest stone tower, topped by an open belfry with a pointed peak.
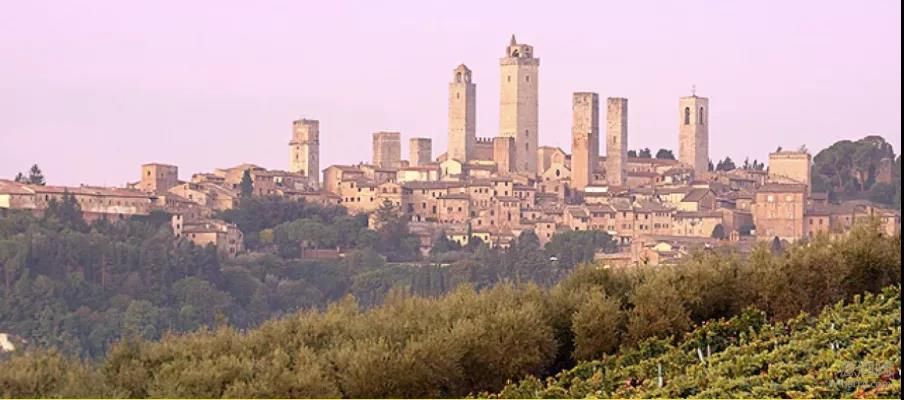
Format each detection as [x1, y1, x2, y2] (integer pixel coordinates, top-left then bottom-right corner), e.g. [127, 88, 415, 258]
[499, 35, 540, 174]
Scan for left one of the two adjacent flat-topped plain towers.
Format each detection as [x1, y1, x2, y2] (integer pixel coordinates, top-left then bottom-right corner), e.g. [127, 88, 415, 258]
[571, 92, 600, 190]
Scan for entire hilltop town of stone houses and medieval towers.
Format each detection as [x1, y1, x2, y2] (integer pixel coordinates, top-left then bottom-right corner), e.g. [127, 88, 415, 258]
[0, 36, 900, 265]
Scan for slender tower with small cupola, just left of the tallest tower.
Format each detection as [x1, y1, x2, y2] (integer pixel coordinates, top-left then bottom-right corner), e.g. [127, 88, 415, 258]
[446, 64, 477, 162]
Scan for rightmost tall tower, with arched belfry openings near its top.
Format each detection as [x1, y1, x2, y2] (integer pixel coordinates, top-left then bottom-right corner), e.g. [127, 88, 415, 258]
[678, 93, 709, 177]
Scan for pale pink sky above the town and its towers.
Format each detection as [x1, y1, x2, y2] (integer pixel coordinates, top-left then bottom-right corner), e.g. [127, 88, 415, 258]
[0, 0, 901, 185]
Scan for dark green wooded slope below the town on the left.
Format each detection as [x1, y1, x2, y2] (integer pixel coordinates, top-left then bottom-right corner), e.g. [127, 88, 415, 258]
[0, 195, 609, 357]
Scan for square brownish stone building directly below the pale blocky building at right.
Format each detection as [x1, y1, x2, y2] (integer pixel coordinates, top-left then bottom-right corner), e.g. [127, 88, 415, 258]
[751, 183, 807, 242]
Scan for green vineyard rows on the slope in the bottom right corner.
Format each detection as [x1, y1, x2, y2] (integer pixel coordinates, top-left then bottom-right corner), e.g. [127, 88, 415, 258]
[490, 287, 901, 398]
